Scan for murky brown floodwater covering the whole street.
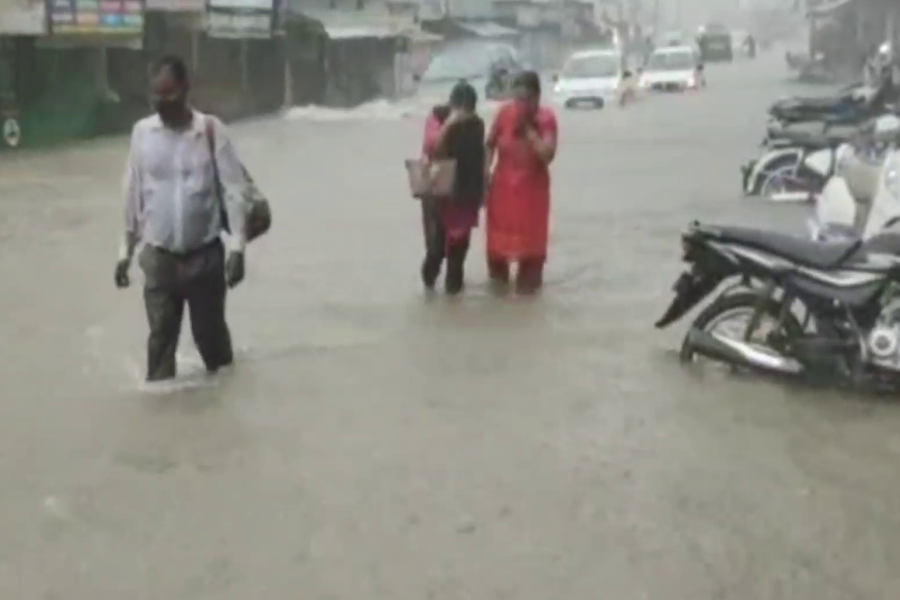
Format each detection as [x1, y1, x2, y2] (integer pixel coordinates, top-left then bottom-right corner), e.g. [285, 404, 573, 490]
[0, 53, 900, 600]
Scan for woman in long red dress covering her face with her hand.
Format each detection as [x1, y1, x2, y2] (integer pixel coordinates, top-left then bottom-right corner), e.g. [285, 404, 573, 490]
[487, 71, 558, 294]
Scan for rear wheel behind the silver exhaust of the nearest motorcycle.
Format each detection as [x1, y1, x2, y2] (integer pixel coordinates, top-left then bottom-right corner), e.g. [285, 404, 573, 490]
[678, 290, 803, 370]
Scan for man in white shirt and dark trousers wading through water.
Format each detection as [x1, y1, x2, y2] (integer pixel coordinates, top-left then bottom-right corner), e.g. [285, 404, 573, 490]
[115, 57, 246, 381]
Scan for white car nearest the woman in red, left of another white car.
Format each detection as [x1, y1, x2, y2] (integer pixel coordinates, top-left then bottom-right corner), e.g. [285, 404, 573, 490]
[553, 49, 624, 108]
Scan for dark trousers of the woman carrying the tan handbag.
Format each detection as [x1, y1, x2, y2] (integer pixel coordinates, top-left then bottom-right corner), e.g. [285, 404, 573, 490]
[422, 198, 471, 294]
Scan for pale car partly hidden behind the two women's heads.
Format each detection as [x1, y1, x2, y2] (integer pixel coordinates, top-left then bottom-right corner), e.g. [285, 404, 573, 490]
[418, 39, 527, 102]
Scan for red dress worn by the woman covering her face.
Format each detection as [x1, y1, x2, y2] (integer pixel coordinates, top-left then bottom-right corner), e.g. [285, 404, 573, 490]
[486, 102, 558, 262]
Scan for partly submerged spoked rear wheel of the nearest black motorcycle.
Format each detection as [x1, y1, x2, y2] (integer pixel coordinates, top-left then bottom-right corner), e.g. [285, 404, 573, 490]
[679, 291, 803, 373]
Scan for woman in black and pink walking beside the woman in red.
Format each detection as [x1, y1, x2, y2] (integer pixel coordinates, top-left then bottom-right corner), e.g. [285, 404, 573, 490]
[422, 81, 485, 294]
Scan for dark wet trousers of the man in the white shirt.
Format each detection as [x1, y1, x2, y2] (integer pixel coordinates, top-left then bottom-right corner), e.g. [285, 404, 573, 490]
[140, 240, 234, 381]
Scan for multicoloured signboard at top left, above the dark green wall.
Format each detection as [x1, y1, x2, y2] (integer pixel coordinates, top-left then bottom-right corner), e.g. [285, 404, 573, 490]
[47, 0, 144, 35]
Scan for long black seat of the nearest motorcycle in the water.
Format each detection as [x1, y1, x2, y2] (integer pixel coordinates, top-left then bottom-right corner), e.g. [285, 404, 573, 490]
[704, 227, 862, 269]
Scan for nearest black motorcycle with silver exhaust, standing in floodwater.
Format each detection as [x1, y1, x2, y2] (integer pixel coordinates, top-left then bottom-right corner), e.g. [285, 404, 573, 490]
[656, 222, 900, 389]
